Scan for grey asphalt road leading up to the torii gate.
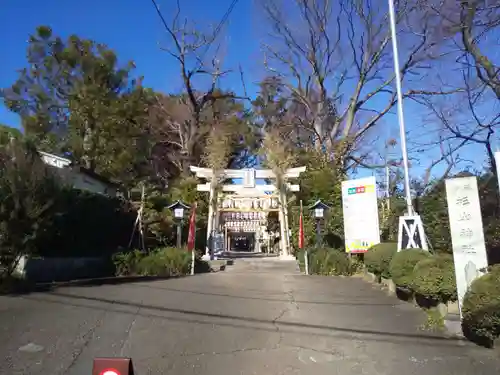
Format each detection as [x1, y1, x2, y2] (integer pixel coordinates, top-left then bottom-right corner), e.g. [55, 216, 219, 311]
[0, 259, 500, 375]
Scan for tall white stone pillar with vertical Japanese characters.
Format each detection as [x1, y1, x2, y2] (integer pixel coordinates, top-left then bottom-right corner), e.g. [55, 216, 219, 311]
[446, 177, 488, 315]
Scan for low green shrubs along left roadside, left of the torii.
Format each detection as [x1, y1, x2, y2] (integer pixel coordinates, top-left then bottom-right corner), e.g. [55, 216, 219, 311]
[113, 247, 210, 277]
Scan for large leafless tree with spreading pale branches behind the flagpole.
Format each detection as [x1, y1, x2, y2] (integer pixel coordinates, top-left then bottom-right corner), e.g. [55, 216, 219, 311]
[263, 0, 448, 172]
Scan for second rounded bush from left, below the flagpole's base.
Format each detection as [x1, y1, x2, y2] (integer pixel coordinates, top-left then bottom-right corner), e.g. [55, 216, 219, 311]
[389, 249, 431, 289]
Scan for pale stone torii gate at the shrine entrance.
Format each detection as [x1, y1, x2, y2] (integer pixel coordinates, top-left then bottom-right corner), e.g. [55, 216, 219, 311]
[190, 166, 306, 259]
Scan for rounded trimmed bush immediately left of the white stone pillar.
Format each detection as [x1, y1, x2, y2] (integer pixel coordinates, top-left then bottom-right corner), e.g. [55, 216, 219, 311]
[411, 254, 457, 303]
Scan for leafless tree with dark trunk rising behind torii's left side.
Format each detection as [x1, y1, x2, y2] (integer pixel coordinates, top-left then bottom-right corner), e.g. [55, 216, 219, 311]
[153, 0, 254, 174]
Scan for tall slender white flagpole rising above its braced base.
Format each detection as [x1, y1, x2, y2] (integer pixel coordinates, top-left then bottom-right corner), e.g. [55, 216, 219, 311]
[388, 0, 413, 216]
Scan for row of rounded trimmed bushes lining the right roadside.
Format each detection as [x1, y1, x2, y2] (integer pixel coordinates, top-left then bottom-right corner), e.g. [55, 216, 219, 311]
[365, 243, 500, 346]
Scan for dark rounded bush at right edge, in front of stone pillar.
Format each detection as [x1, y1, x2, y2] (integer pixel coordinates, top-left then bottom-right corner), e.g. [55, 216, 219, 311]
[462, 264, 500, 347]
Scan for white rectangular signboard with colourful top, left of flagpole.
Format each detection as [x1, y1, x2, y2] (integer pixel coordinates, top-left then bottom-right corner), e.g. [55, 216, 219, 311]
[342, 177, 380, 253]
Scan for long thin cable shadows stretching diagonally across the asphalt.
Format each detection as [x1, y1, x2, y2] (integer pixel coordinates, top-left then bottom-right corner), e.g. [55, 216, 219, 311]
[26, 292, 465, 347]
